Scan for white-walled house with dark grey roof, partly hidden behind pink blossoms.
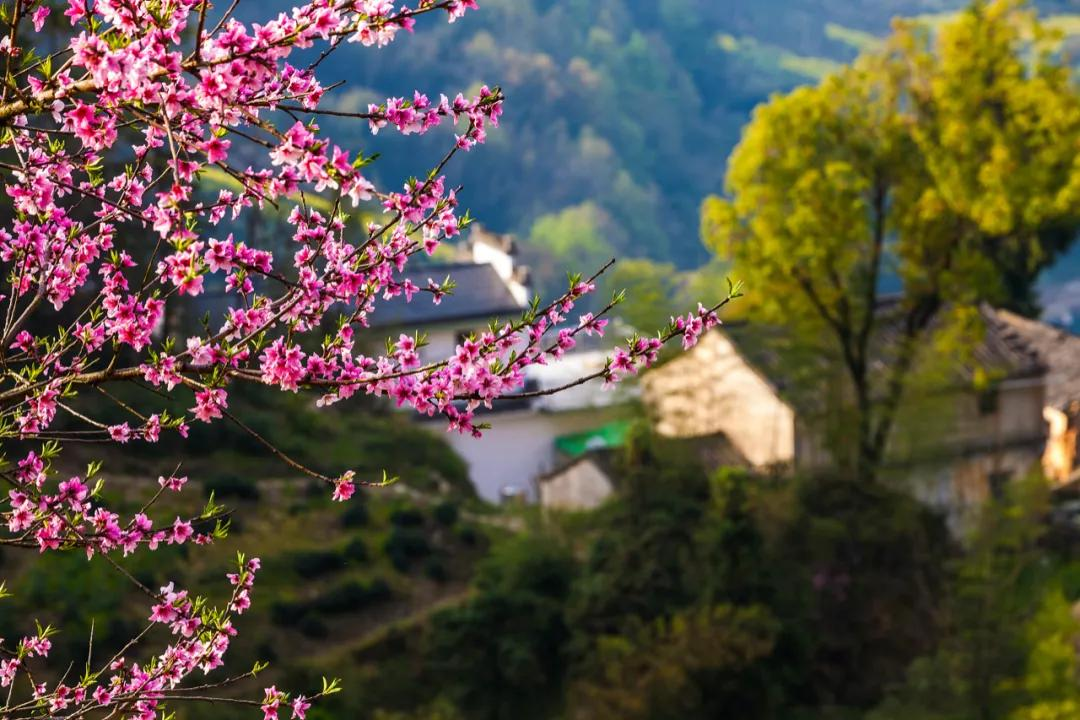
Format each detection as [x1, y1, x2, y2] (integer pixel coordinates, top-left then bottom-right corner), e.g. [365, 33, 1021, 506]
[373, 226, 637, 502]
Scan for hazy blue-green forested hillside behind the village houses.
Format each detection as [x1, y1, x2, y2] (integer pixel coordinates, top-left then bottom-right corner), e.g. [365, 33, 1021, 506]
[241, 0, 1076, 284]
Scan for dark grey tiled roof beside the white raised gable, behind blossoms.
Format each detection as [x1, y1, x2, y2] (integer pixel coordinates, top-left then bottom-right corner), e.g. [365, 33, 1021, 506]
[372, 262, 522, 328]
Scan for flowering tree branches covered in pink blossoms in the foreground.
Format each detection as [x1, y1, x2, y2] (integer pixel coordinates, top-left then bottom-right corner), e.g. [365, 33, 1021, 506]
[0, 0, 738, 720]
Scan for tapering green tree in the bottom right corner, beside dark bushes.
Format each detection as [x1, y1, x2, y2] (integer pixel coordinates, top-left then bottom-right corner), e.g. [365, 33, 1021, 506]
[870, 478, 1058, 720]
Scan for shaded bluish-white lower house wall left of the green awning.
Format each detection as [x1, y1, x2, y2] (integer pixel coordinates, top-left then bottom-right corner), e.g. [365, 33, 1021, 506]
[431, 408, 619, 502]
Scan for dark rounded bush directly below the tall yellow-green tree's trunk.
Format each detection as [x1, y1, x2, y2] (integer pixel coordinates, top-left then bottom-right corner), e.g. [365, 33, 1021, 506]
[767, 477, 954, 708]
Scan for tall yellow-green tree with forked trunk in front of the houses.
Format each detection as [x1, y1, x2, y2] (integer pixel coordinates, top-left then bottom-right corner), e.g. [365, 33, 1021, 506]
[702, 0, 1080, 479]
